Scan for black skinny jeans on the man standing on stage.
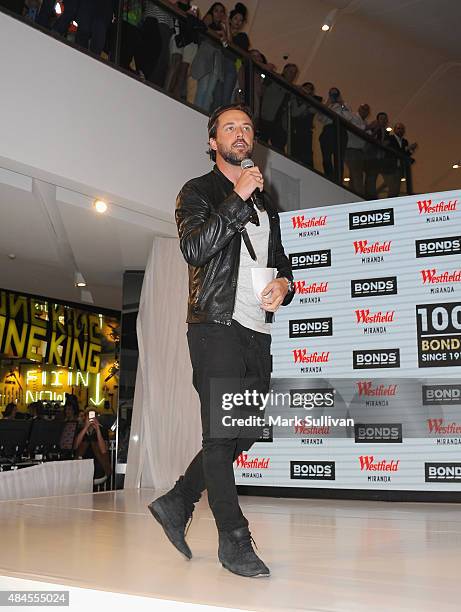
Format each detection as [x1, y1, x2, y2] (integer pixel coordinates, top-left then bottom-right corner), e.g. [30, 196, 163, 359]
[175, 321, 271, 531]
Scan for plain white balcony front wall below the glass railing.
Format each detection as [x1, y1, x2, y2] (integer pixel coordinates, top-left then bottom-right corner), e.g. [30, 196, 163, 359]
[0, 13, 360, 234]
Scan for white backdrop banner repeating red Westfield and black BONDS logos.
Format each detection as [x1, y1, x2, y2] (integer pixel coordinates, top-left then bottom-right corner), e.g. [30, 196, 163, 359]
[235, 192, 461, 491]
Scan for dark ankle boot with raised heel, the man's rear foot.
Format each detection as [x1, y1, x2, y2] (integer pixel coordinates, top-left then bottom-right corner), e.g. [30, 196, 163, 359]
[147, 488, 193, 559]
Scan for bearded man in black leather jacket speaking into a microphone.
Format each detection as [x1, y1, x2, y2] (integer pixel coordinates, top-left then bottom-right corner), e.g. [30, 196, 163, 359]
[149, 105, 294, 577]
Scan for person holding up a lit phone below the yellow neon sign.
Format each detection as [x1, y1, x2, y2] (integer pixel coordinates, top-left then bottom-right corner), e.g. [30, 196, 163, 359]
[74, 408, 112, 485]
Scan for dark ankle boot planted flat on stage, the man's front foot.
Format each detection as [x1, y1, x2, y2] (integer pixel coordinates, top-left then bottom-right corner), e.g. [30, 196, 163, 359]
[218, 527, 270, 578]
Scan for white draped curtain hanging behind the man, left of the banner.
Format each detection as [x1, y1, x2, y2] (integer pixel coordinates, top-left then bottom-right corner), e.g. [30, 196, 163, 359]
[125, 238, 201, 489]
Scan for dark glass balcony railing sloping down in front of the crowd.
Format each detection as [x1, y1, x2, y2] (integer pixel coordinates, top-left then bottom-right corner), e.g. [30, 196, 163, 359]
[0, 0, 413, 199]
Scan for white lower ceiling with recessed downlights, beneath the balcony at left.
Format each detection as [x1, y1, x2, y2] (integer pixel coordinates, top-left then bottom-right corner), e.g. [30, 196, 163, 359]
[0, 170, 154, 310]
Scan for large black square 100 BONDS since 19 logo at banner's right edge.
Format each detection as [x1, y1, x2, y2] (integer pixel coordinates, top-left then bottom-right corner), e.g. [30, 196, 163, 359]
[416, 302, 461, 368]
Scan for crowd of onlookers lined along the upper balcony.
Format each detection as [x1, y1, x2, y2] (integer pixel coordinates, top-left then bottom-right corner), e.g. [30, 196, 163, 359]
[0, 0, 417, 199]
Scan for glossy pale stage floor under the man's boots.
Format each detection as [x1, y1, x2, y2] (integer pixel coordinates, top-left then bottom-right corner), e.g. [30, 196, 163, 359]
[0, 489, 461, 612]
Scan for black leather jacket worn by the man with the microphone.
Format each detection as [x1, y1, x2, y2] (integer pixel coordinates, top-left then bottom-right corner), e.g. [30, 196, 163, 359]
[176, 165, 294, 325]
